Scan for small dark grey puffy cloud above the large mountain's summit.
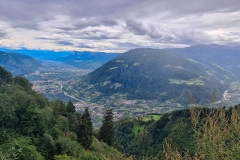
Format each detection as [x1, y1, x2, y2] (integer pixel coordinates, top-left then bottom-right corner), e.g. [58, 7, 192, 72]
[126, 20, 148, 35]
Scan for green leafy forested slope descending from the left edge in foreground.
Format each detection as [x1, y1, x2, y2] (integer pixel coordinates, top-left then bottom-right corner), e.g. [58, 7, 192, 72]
[0, 66, 123, 160]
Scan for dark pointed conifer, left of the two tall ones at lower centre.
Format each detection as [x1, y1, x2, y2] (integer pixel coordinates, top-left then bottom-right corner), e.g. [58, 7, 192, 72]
[77, 108, 93, 149]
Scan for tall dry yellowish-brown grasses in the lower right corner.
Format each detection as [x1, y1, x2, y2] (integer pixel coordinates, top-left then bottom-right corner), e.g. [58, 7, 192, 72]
[164, 105, 240, 160]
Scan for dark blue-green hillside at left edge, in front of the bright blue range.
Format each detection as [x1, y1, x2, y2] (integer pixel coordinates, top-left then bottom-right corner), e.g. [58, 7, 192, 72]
[0, 51, 42, 75]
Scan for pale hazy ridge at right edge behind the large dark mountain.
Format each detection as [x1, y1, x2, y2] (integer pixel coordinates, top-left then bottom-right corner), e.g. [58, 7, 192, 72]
[166, 44, 240, 82]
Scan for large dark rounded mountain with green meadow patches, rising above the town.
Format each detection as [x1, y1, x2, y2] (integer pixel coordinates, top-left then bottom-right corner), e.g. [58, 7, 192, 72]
[85, 49, 226, 104]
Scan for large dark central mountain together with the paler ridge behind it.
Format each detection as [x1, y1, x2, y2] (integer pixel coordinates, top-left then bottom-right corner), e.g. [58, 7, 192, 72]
[85, 45, 240, 104]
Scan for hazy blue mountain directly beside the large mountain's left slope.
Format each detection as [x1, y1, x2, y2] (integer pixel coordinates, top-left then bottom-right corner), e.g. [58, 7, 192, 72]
[58, 51, 118, 70]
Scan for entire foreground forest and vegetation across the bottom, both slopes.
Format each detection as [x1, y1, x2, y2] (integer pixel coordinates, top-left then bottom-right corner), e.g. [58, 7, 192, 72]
[0, 67, 240, 160]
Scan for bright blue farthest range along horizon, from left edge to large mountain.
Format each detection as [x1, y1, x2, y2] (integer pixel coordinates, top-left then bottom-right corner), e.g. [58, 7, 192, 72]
[0, 48, 118, 70]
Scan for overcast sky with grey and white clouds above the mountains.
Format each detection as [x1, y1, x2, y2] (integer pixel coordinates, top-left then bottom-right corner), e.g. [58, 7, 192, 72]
[0, 0, 240, 52]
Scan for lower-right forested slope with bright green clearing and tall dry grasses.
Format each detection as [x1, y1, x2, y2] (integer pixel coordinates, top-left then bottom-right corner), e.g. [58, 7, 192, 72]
[114, 105, 240, 160]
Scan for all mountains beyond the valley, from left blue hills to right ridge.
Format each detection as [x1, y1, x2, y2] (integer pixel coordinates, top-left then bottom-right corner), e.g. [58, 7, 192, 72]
[0, 44, 240, 104]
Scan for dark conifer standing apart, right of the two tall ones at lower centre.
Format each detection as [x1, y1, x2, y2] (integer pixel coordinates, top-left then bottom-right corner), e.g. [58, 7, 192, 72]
[99, 109, 113, 146]
